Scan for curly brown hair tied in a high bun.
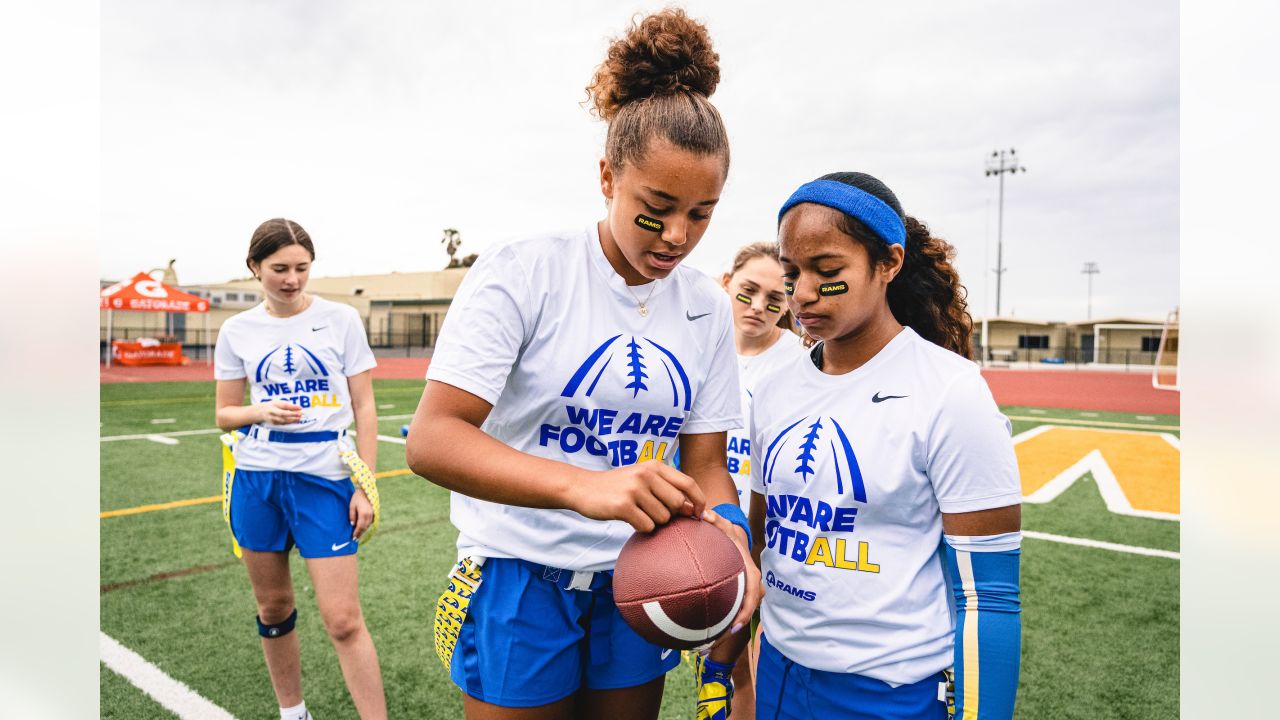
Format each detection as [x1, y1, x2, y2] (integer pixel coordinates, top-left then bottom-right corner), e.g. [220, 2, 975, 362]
[586, 8, 728, 172]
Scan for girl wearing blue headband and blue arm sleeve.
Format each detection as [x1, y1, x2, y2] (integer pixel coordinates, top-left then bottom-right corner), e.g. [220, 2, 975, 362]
[727, 173, 1021, 720]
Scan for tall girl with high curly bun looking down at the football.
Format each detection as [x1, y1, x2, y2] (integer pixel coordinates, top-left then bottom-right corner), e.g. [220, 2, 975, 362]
[407, 10, 763, 720]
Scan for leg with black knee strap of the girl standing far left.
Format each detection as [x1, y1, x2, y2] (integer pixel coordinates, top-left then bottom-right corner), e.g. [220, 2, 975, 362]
[244, 550, 302, 707]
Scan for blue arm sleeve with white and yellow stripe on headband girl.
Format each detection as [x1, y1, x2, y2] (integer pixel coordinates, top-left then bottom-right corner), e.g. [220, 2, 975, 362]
[943, 533, 1023, 720]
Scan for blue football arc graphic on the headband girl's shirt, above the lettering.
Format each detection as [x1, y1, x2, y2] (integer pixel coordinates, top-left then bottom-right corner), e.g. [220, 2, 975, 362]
[762, 415, 867, 502]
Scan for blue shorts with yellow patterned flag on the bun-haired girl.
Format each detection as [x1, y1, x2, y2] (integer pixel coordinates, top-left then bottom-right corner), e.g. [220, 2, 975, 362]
[435, 557, 680, 707]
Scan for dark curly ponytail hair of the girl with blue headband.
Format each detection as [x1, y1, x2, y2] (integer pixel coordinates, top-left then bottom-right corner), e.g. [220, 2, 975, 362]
[818, 173, 973, 357]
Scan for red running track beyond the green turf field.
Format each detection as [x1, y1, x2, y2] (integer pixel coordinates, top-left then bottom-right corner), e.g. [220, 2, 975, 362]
[99, 357, 1179, 415]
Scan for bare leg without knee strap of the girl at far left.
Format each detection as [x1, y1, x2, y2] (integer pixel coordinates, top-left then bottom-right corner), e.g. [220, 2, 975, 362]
[307, 555, 387, 720]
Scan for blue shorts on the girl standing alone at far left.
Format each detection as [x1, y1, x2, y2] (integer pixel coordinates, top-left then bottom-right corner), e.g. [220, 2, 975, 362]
[230, 468, 360, 557]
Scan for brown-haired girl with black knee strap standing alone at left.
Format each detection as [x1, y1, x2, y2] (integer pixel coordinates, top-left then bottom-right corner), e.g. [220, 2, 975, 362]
[214, 218, 387, 720]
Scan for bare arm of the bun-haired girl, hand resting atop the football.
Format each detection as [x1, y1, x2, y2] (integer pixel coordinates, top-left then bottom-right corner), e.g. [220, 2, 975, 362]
[404, 380, 706, 532]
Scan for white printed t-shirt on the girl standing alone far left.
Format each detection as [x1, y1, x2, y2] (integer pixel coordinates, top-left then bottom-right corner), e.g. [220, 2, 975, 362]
[214, 296, 378, 480]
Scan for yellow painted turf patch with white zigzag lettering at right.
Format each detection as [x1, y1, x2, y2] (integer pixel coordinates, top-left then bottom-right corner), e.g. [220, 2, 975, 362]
[1014, 425, 1181, 520]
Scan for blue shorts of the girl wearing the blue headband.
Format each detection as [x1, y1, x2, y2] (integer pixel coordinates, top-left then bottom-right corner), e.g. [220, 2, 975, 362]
[755, 634, 947, 720]
